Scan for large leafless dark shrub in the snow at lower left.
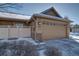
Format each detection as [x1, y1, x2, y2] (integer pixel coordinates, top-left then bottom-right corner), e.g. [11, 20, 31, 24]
[0, 40, 38, 56]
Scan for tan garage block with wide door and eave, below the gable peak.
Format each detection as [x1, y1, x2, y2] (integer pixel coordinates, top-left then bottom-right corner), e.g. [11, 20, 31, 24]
[32, 14, 70, 40]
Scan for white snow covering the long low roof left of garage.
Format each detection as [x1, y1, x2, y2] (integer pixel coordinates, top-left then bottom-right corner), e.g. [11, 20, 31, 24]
[0, 12, 31, 20]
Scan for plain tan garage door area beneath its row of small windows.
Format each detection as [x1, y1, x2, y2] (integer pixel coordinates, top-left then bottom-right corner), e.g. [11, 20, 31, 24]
[42, 26, 66, 39]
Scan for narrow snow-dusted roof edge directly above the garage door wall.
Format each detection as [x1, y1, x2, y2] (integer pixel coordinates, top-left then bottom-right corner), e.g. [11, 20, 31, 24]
[33, 13, 70, 22]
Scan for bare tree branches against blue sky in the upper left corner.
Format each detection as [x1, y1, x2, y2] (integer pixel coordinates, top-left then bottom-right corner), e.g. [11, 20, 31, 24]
[0, 3, 22, 12]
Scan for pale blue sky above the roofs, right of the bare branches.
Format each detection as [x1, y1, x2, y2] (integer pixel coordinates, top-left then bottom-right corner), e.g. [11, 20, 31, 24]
[0, 3, 79, 24]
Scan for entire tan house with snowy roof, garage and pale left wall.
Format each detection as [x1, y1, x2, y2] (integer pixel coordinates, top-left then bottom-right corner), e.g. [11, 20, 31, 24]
[0, 7, 70, 40]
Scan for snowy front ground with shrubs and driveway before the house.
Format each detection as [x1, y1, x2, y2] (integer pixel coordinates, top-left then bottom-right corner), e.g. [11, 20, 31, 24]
[0, 33, 79, 56]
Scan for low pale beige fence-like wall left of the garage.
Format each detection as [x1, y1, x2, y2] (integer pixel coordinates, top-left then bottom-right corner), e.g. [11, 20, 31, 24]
[0, 27, 31, 39]
